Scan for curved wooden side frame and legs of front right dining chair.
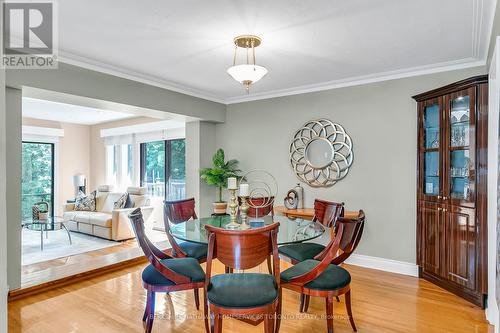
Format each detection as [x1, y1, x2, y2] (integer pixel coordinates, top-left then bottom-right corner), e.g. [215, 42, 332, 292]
[278, 223, 356, 333]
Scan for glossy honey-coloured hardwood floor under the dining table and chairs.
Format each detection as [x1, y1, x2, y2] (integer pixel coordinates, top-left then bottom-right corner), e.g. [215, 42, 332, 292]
[9, 263, 491, 333]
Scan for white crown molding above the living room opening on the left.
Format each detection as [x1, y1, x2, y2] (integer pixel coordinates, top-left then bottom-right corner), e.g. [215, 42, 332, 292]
[58, 50, 225, 104]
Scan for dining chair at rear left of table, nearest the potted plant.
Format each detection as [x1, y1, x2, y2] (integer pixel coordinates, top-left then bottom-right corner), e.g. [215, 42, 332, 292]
[163, 198, 207, 263]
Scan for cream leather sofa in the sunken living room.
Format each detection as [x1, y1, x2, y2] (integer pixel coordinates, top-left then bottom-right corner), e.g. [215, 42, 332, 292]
[63, 185, 153, 241]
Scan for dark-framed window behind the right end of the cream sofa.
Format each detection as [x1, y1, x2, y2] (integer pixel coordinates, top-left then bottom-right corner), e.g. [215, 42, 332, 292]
[141, 139, 186, 200]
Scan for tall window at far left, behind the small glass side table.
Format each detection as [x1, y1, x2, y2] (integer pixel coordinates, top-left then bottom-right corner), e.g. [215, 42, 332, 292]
[21, 142, 54, 218]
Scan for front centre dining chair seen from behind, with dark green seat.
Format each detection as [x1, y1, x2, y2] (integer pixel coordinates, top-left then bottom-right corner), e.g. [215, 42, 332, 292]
[204, 223, 281, 333]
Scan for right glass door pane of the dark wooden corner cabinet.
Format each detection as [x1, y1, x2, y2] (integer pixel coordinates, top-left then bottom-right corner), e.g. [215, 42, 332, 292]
[447, 89, 475, 202]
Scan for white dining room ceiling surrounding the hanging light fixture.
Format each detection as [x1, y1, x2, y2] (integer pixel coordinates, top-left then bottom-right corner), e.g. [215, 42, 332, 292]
[58, 0, 496, 103]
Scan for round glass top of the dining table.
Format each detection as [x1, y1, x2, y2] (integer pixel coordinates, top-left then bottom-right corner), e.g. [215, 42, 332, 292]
[170, 215, 325, 245]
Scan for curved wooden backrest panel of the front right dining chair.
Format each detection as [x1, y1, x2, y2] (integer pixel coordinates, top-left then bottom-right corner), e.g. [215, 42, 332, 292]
[332, 210, 365, 265]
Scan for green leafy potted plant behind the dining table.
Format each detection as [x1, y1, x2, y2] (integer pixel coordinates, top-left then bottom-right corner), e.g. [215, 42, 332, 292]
[200, 148, 241, 214]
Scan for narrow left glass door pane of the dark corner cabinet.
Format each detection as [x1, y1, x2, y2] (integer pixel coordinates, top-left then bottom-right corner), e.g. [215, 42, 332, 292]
[422, 100, 441, 196]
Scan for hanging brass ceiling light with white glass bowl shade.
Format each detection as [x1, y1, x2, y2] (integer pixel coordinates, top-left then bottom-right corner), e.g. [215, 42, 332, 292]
[227, 35, 267, 94]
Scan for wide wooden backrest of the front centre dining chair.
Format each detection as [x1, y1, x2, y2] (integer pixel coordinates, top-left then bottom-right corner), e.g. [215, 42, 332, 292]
[205, 223, 279, 270]
